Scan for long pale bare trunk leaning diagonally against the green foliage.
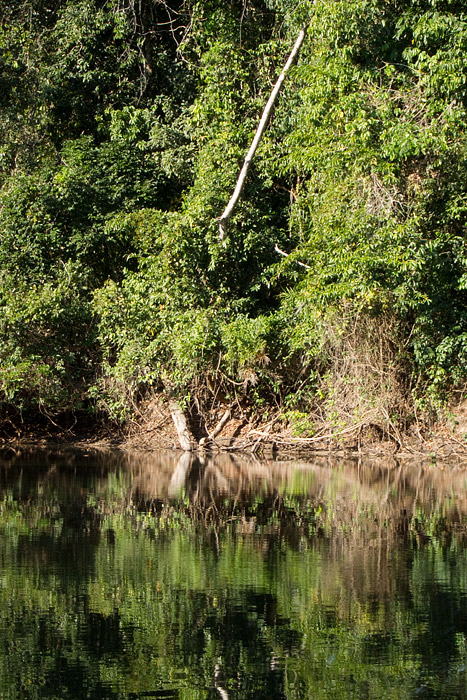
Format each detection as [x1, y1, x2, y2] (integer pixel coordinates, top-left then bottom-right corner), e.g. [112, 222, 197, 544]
[219, 27, 307, 241]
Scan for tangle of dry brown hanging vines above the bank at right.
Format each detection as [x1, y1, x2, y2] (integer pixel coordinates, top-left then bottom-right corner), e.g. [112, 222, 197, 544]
[317, 315, 415, 448]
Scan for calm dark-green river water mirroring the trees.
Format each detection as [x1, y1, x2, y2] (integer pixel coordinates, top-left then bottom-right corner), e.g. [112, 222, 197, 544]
[0, 450, 467, 700]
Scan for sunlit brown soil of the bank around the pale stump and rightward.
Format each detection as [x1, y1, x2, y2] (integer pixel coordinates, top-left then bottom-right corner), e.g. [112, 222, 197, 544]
[123, 398, 467, 459]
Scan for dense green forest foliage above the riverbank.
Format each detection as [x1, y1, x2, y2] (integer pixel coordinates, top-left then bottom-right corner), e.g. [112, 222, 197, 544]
[0, 0, 467, 436]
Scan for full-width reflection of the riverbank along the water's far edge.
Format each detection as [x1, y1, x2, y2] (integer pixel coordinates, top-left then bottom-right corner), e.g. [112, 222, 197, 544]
[0, 448, 467, 529]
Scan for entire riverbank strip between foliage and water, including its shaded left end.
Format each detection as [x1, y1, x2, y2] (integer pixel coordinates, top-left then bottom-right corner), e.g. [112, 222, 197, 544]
[0, 395, 467, 459]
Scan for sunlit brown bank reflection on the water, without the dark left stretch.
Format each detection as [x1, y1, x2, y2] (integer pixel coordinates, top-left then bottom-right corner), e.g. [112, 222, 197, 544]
[122, 453, 467, 525]
